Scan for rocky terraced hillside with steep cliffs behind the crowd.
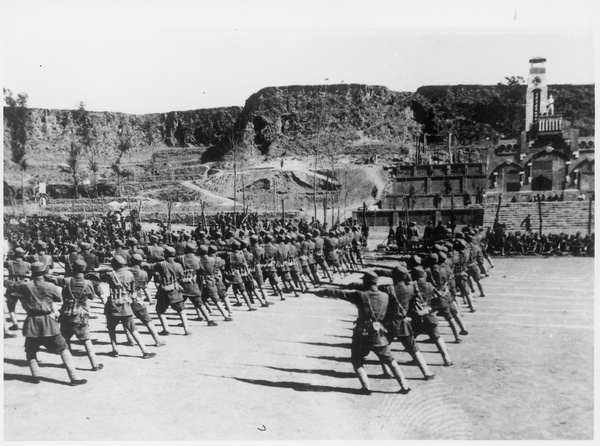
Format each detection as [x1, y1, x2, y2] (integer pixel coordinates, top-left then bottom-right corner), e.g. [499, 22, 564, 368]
[4, 84, 595, 213]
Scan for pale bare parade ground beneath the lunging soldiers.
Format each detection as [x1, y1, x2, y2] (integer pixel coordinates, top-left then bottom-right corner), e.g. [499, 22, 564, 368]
[4, 253, 594, 441]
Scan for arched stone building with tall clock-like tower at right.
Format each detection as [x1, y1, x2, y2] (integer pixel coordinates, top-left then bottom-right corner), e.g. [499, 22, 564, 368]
[487, 57, 595, 199]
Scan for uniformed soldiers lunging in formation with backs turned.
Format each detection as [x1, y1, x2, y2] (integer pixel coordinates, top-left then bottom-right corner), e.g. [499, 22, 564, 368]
[4, 222, 492, 394]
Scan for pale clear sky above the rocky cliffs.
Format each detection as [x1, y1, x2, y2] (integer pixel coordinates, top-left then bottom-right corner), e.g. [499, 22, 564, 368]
[1, 0, 599, 114]
